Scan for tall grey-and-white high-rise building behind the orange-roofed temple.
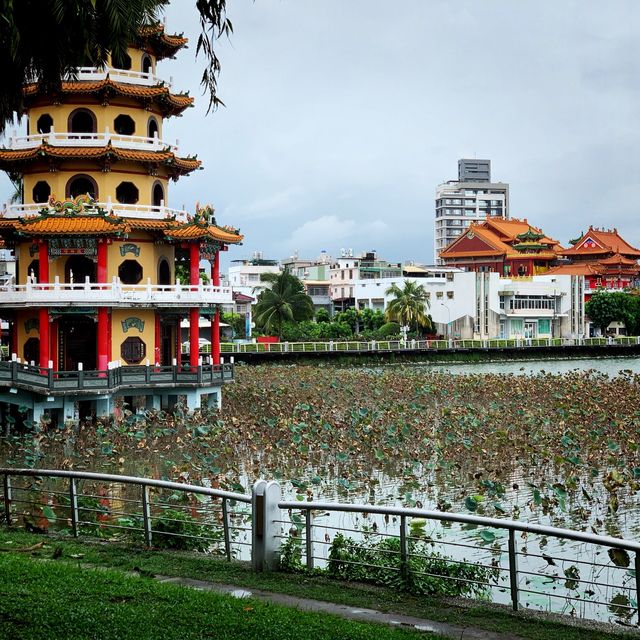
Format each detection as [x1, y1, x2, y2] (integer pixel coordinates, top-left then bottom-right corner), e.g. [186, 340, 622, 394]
[433, 159, 509, 265]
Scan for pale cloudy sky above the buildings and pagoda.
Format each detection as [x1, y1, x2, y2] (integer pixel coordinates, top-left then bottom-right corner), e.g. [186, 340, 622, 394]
[0, 0, 640, 267]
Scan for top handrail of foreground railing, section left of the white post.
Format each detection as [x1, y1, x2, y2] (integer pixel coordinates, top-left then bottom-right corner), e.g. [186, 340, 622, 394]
[0, 467, 251, 503]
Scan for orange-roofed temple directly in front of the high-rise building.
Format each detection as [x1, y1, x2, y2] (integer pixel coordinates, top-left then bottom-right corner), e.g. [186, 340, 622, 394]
[440, 218, 563, 277]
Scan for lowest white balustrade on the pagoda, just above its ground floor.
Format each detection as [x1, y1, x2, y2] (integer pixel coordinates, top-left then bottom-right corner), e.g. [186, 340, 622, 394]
[0, 279, 233, 309]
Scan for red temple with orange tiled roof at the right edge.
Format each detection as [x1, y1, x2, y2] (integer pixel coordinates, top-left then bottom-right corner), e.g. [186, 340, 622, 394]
[549, 226, 640, 302]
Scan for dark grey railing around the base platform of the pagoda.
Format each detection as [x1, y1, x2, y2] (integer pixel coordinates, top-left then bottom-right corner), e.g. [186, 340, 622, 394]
[0, 360, 234, 395]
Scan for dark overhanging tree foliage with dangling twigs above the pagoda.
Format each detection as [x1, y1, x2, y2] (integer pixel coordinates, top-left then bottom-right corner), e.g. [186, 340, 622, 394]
[0, 0, 233, 133]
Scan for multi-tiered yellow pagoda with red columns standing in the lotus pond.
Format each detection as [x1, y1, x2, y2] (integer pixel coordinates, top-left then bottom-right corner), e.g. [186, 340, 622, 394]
[0, 25, 242, 422]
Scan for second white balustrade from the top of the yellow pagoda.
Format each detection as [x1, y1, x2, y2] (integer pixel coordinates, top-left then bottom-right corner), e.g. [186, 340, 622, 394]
[7, 127, 178, 154]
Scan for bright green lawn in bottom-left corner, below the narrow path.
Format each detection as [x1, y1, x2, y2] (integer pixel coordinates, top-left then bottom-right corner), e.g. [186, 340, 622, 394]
[0, 553, 435, 640]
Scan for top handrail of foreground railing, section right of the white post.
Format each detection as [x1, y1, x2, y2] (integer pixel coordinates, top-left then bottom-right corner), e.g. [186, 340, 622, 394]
[278, 500, 640, 552]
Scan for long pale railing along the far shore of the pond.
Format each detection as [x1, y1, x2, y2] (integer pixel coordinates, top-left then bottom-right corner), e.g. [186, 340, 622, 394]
[220, 336, 640, 354]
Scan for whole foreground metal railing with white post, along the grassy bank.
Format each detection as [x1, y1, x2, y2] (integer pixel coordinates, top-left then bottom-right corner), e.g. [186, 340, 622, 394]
[0, 468, 640, 622]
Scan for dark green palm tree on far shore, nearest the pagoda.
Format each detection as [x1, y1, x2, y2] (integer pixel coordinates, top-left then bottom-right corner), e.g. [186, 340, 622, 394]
[254, 271, 313, 337]
